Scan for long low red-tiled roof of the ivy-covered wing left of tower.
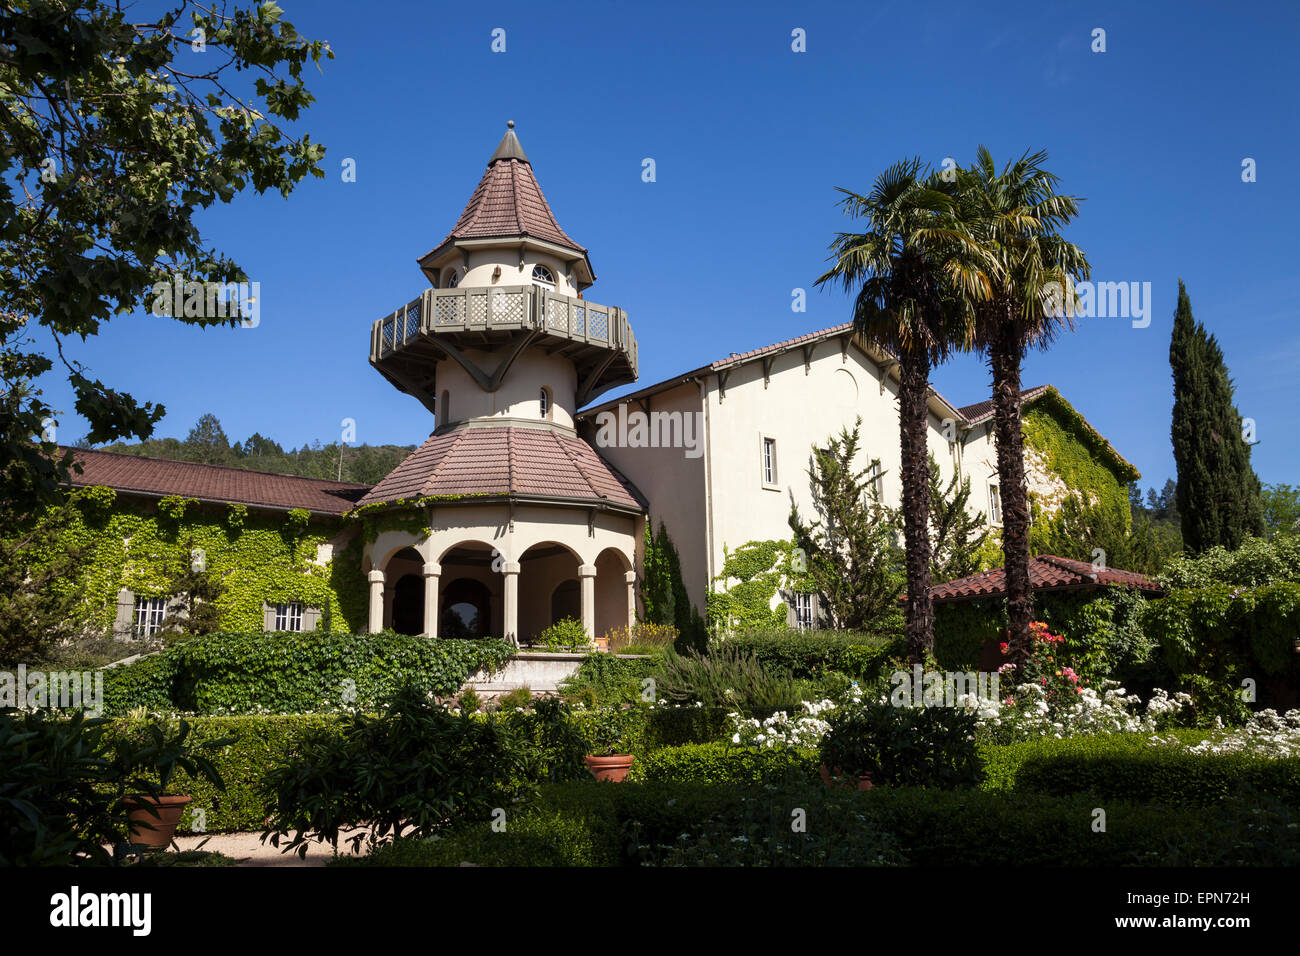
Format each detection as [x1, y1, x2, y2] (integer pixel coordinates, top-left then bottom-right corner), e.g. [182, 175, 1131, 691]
[64, 449, 369, 515]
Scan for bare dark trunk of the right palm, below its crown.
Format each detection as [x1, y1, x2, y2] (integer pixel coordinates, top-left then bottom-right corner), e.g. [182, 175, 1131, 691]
[989, 315, 1034, 665]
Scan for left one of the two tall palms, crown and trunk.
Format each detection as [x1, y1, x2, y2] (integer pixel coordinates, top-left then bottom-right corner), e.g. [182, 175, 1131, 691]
[816, 159, 988, 661]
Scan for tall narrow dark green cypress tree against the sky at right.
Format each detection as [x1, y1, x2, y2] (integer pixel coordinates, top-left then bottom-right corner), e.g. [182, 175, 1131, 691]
[1169, 280, 1264, 553]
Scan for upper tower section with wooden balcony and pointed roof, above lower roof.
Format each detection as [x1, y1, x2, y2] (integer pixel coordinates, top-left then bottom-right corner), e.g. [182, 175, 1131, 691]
[371, 122, 637, 432]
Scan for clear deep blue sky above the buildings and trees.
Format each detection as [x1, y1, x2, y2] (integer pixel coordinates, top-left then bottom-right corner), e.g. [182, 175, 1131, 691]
[43, 0, 1300, 486]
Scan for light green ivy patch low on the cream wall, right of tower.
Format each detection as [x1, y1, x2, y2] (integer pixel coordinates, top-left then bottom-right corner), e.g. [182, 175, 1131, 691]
[706, 541, 816, 631]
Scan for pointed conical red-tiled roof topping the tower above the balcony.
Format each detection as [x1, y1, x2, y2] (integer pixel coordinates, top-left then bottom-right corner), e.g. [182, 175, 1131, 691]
[436, 122, 586, 255]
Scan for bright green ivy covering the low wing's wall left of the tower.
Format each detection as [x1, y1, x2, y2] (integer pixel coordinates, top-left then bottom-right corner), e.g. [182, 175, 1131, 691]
[38, 488, 368, 633]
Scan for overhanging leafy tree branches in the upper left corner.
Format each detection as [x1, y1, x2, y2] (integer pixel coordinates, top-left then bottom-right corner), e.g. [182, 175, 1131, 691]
[0, 0, 333, 509]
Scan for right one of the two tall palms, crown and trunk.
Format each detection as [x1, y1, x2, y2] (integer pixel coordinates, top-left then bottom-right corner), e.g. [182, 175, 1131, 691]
[957, 146, 1089, 662]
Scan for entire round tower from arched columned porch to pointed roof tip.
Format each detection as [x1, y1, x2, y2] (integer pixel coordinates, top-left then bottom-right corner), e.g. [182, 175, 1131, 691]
[359, 124, 646, 641]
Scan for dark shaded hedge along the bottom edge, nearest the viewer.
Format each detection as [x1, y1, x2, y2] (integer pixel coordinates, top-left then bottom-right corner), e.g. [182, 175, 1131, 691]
[340, 782, 1300, 866]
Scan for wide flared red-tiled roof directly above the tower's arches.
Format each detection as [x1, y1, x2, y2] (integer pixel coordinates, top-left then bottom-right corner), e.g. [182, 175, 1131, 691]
[359, 425, 644, 511]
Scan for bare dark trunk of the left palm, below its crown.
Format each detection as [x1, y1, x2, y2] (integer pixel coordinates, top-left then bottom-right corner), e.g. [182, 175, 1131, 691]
[898, 350, 935, 663]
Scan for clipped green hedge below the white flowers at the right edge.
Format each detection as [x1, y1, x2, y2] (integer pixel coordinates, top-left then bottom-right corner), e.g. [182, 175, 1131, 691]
[988, 735, 1300, 808]
